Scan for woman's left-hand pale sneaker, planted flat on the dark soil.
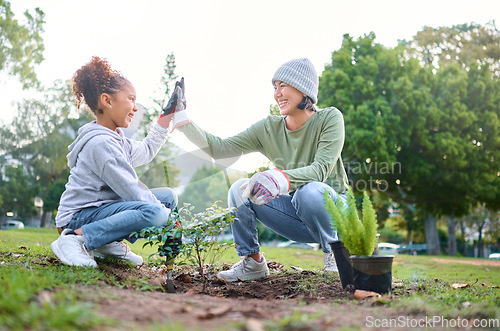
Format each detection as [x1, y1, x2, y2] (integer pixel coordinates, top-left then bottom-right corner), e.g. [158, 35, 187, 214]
[217, 255, 269, 282]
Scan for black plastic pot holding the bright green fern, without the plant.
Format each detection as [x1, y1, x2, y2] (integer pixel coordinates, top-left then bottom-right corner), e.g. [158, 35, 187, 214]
[350, 255, 394, 294]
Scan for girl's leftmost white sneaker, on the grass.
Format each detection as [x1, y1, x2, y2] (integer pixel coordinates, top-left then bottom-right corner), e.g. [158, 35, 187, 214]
[50, 229, 97, 268]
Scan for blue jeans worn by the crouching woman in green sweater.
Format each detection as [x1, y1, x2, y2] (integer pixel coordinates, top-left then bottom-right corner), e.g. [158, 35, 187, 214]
[228, 179, 346, 256]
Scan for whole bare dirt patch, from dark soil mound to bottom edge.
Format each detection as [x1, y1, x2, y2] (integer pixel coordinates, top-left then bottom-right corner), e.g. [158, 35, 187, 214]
[85, 261, 406, 330]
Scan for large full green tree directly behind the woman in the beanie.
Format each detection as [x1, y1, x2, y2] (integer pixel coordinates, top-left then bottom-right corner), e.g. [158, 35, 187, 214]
[319, 26, 500, 254]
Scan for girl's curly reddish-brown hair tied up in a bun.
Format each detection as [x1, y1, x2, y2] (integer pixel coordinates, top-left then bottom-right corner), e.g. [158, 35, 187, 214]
[71, 56, 130, 115]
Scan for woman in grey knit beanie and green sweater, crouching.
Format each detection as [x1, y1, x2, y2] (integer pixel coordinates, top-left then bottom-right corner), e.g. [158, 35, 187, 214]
[174, 58, 348, 282]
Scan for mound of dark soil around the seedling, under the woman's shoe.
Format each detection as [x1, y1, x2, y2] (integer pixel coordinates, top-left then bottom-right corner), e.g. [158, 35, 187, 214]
[99, 261, 352, 302]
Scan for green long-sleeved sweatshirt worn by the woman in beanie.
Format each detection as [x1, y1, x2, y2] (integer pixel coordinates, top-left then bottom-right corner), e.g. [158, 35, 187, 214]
[179, 107, 348, 193]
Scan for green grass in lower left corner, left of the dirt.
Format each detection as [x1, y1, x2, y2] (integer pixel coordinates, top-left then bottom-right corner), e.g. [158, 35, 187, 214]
[0, 233, 113, 330]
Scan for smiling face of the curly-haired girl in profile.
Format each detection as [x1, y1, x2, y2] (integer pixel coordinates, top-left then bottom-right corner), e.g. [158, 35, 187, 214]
[99, 84, 138, 130]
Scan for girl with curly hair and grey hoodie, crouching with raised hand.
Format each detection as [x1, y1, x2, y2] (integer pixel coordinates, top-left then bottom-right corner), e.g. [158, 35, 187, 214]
[50, 57, 181, 267]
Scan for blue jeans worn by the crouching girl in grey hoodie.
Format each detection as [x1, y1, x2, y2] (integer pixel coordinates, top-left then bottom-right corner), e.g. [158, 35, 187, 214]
[66, 188, 177, 251]
